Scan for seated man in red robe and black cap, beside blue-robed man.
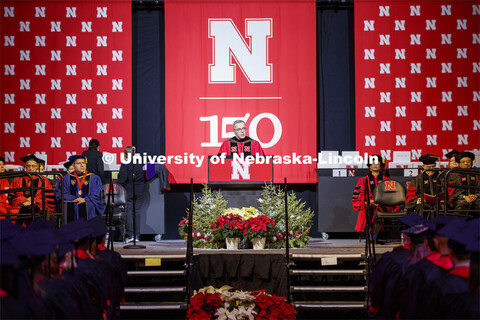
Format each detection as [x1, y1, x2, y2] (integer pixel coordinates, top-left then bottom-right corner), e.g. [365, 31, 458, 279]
[8, 154, 55, 223]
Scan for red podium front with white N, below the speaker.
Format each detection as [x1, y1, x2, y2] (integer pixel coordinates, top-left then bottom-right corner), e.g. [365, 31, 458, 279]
[208, 156, 273, 185]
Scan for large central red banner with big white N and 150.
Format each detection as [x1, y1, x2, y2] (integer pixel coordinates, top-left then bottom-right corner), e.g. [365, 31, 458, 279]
[165, 0, 316, 183]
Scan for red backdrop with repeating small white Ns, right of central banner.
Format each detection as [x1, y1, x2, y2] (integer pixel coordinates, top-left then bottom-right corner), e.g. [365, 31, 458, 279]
[355, 1, 480, 160]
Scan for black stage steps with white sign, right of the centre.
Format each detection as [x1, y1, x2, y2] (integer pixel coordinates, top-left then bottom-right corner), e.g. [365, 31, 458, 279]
[290, 253, 367, 319]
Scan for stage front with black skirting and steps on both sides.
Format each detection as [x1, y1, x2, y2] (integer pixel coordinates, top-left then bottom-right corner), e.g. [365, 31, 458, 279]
[114, 239, 400, 319]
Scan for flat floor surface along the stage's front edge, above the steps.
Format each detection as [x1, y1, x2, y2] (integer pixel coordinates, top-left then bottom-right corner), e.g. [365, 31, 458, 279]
[113, 239, 400, 256]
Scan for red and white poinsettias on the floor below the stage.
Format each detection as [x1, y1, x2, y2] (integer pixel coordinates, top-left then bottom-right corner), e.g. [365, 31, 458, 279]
[188, 286, 297, 320]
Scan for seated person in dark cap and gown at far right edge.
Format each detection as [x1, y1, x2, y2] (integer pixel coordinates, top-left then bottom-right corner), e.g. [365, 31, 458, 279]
[452, 151, 480, 217]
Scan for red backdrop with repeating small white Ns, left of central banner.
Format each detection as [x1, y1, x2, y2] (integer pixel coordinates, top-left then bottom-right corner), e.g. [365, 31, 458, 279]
[0, 0, 132, 165]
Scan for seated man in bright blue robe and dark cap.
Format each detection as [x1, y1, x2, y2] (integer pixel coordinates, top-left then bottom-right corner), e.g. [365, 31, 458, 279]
[56, 155, 105, 223]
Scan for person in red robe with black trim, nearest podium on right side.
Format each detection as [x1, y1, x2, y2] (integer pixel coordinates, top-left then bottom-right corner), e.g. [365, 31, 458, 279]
[352, 155, 394, 233]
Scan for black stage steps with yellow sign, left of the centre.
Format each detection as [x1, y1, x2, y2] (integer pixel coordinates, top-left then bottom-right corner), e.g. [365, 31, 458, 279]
[120, 254, 187, 319]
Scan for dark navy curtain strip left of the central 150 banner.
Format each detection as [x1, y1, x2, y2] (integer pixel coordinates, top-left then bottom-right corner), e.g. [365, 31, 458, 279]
[132, 5, 165, 155]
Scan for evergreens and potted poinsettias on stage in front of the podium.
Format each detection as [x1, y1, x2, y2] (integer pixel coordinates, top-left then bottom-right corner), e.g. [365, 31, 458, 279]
[178, 185, 314, 248]
